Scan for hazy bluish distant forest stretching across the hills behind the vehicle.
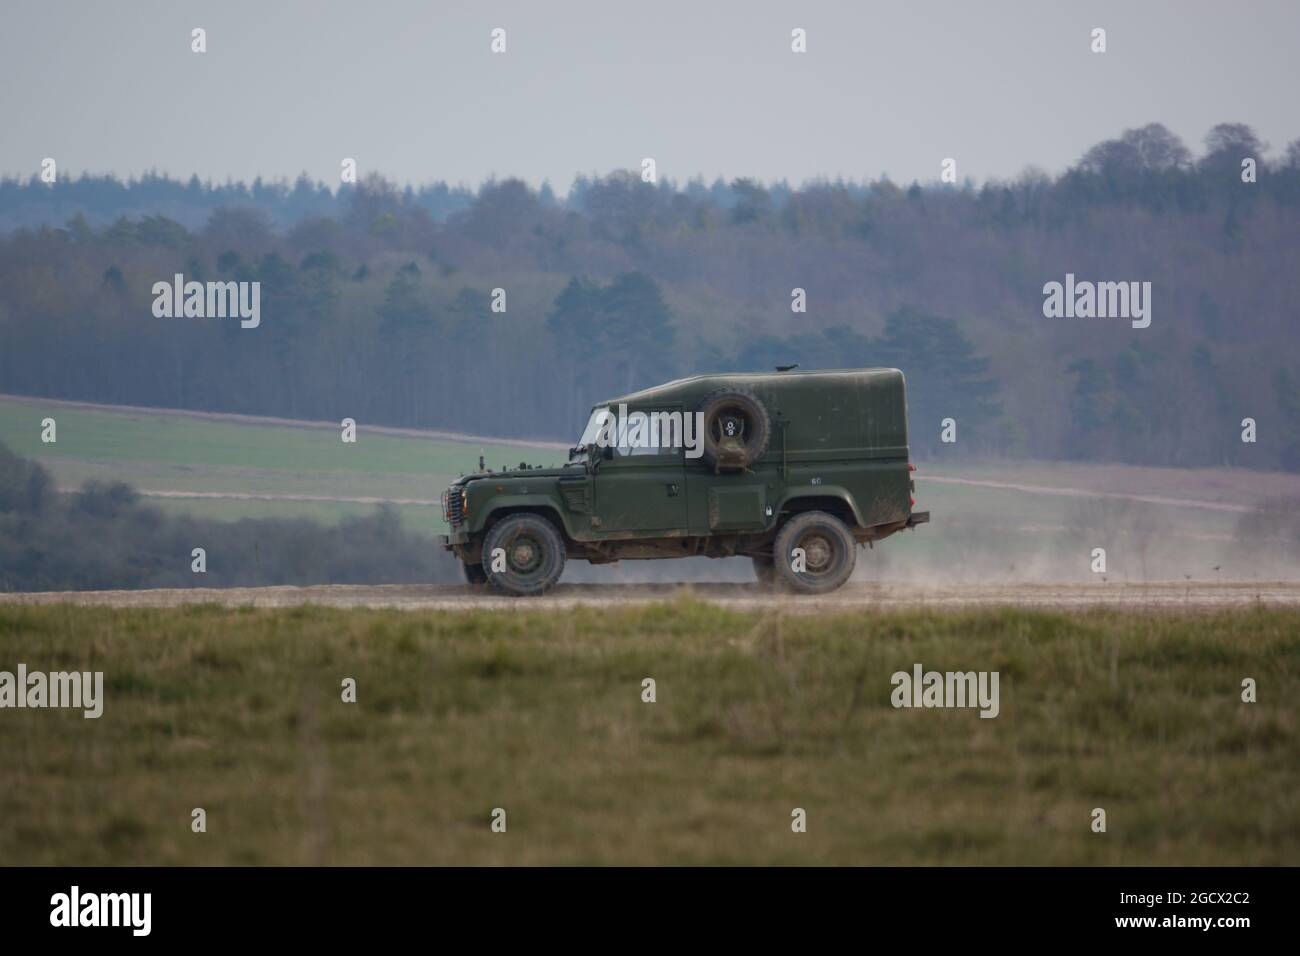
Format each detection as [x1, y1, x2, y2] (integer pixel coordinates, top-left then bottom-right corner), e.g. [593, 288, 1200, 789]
[0, 124, 1300, 471]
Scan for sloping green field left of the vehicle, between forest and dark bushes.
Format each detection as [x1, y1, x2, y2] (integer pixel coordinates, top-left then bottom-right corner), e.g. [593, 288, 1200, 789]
[0, 398, 564, 531]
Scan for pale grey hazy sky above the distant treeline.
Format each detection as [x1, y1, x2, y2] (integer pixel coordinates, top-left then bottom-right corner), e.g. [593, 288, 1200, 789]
[0, 0, 1300, 193]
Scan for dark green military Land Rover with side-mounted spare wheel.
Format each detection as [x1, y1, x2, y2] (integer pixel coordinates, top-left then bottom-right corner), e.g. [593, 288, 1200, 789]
[442, 368, 930, 596]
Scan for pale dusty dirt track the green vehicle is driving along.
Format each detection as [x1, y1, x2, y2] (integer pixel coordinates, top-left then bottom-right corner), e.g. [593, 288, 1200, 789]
[0, 581, 1300, 614]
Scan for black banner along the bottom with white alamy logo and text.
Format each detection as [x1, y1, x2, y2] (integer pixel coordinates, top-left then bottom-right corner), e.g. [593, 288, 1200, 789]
[0, 868, 1279, 952]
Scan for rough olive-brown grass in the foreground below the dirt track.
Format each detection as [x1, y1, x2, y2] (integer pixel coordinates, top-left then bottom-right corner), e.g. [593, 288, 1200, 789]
[0, 606, 1300, 865]
